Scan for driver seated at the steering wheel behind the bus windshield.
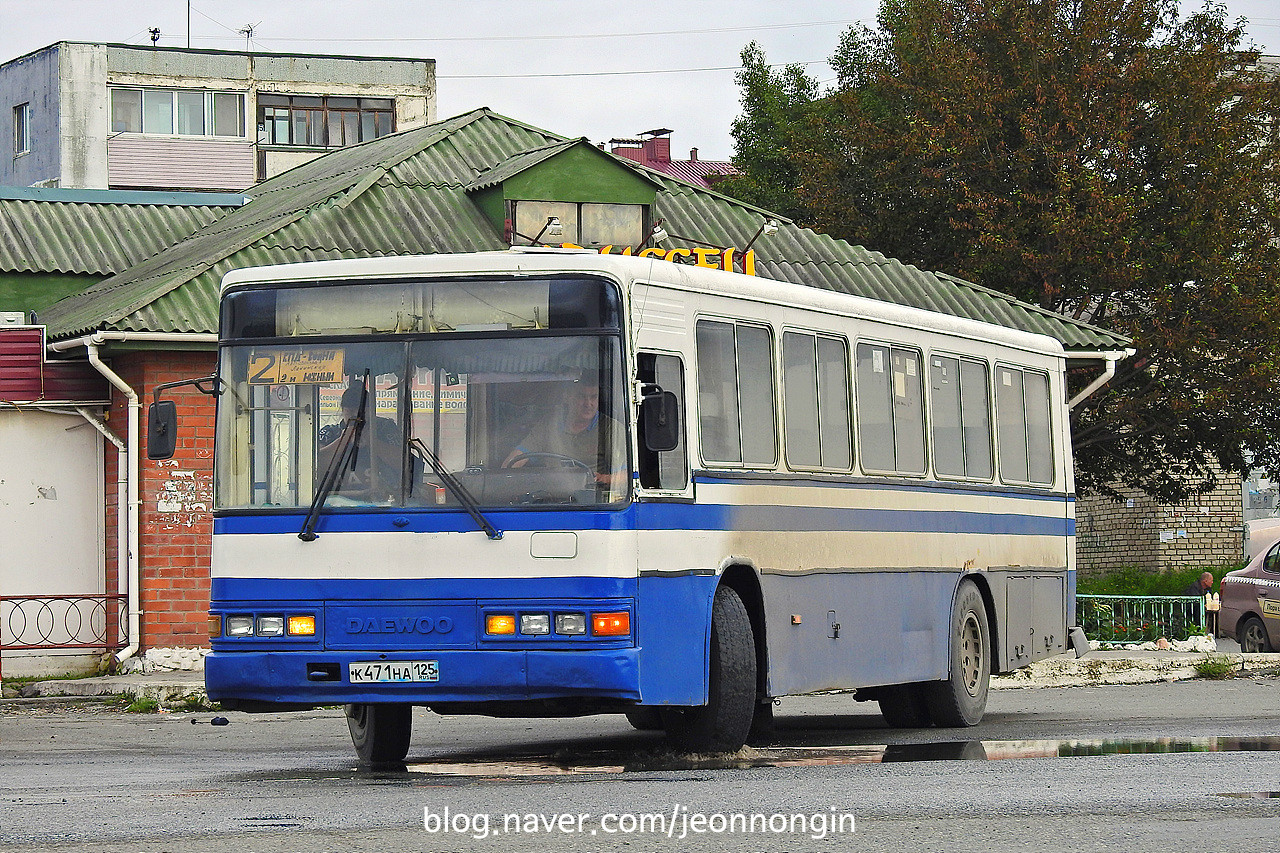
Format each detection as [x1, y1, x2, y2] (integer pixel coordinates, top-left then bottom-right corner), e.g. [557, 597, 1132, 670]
[503, 370, 627, 489]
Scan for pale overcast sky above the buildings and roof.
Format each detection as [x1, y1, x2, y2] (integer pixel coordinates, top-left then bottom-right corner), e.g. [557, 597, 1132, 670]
[0, 0, 1280, 160]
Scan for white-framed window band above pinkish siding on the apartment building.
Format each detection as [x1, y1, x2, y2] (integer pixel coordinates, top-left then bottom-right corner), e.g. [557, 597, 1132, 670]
[111, 87, 244, 138]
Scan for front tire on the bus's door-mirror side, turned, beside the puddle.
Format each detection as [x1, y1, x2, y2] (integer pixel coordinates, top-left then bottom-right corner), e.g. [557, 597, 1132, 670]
[663, 585, 755, 752]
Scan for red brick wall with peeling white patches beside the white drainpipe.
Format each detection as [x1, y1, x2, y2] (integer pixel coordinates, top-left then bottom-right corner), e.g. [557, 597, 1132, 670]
[104, 351, 215, 649]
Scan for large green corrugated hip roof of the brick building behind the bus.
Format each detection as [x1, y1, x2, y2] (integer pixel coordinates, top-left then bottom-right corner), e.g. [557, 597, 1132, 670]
[41, 109, 1126, 350]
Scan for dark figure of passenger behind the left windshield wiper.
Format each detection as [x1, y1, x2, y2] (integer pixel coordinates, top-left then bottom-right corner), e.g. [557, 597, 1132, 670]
[316, 382, 404, 503]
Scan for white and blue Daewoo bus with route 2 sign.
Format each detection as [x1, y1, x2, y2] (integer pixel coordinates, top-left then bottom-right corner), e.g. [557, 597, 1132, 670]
[162, 248, 1075, 763]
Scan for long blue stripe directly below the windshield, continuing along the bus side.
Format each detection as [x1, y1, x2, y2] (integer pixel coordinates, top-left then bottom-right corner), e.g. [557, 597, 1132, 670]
[214, 503, 1075, 537]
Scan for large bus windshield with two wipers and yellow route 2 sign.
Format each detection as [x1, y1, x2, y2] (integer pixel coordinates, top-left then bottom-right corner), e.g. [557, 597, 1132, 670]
[215, 277, 631, 511]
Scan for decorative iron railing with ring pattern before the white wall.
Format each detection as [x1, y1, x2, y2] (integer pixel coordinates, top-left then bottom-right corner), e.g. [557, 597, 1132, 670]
[0, 594, 129, 652]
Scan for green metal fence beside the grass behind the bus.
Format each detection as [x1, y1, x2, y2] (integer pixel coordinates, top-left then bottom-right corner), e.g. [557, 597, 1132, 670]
[1075, 596, 1207, 643]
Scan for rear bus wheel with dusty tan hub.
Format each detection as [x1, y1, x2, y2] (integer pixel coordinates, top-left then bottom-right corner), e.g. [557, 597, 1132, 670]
[924, 580, 991, 727]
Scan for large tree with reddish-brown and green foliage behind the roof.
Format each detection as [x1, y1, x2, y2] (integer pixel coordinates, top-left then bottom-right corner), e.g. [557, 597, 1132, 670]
[735, 0, 1280, 502]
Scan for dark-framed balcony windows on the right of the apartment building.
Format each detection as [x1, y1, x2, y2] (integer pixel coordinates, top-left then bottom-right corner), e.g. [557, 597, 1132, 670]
[257, 95, 396, 149]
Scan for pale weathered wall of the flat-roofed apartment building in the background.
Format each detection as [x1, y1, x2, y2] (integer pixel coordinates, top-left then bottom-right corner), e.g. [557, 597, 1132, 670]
[0, 42, 436, 191]
